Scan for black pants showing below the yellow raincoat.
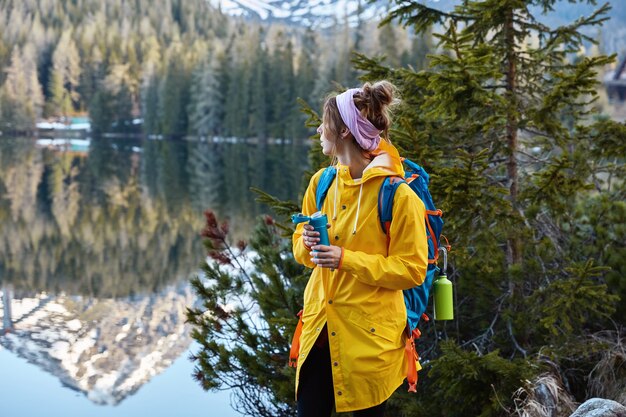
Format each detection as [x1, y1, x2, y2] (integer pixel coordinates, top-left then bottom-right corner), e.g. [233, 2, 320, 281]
[298, 329, 386, 417]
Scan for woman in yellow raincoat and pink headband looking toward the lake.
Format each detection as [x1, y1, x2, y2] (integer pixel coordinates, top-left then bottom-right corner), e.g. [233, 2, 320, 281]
[293, 81, 428, 417]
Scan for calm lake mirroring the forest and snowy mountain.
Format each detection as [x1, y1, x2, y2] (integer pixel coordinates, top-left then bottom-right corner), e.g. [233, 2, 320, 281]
[0, 137, 308, 417]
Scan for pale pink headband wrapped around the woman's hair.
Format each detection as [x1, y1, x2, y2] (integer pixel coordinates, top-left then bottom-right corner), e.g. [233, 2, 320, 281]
[336, 88, 380, 152]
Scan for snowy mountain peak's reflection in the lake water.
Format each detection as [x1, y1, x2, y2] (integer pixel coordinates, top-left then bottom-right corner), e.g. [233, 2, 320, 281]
[0, 284, 194, 405]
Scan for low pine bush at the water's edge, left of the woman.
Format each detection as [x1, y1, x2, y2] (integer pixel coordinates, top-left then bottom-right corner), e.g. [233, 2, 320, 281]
[187, 212, 308, 416]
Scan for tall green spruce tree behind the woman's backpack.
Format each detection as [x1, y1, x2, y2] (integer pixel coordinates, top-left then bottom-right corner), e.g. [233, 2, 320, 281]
[364, 0, 624, 415]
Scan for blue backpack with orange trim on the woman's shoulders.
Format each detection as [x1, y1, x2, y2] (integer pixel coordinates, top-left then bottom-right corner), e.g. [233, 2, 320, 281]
[315, 158, 443, 333]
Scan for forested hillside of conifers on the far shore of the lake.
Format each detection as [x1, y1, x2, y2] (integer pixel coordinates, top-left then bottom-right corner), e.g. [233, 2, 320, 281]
[0, 0, 430, 138]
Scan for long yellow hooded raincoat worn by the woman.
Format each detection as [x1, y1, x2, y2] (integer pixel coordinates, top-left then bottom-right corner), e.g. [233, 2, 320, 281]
[293, 140, 428, 412]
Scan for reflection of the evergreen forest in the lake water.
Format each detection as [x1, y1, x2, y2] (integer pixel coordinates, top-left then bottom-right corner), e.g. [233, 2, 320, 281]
[0, 138, 306, 297]
